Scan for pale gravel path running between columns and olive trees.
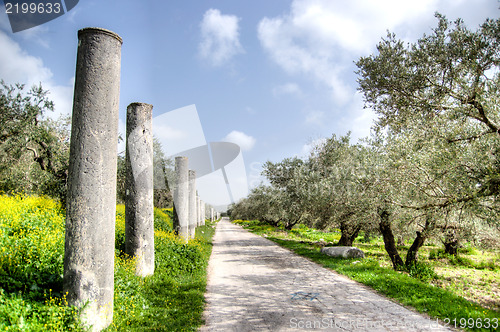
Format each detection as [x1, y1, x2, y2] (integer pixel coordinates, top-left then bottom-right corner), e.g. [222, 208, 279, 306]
[200, 218, 451, 332]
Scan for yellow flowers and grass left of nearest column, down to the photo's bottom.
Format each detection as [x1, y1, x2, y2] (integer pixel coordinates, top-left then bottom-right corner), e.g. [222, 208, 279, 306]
[0, 195, 81, 331]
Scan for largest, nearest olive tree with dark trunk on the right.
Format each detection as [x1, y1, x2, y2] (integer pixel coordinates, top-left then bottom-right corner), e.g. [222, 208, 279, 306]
[357, 14, 500, 266]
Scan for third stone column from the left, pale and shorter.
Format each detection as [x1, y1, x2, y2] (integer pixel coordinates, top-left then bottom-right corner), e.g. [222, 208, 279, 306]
[174, 157, 189, 242]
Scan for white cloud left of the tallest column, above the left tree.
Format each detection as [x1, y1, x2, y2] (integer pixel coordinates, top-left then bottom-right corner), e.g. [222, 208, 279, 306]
[0, 30, 74, 118]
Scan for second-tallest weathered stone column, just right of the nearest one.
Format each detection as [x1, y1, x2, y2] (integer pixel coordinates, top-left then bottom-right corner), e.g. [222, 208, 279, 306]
[125, 103, 155, 276]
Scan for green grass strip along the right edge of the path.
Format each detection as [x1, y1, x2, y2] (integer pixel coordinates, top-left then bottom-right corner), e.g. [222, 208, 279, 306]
[236, 221, 500, 331]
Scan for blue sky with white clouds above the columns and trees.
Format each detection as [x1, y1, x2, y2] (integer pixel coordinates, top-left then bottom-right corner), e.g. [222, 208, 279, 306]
[0, 0, 500, 204]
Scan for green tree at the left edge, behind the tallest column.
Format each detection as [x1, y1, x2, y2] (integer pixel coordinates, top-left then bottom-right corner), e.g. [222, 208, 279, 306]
[0, 81, 70, 202]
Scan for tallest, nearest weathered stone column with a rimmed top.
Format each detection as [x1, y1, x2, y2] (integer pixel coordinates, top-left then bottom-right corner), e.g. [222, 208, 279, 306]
[63, 28, 122, 331]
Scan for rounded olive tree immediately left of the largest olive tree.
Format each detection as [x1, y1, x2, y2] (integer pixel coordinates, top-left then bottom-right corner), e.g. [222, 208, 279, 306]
[307, 133, 376, 246]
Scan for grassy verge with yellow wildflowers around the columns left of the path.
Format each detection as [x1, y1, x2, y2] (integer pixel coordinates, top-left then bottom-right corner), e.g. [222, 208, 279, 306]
[0, 195, 214, 331]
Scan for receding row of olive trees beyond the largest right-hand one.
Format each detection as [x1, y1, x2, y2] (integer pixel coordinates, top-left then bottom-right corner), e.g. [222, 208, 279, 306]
[231, 134, 378, 242]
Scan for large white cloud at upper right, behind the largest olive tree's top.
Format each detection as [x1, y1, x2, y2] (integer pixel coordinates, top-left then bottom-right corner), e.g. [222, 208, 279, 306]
[257, 0, 498, 139]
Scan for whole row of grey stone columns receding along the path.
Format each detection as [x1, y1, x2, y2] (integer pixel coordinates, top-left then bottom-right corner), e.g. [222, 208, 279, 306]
[63, 28, 222, 331]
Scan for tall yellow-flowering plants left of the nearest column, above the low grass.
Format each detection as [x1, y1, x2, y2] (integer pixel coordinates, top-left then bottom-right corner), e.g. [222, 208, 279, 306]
[0, 196, 65, 298]
